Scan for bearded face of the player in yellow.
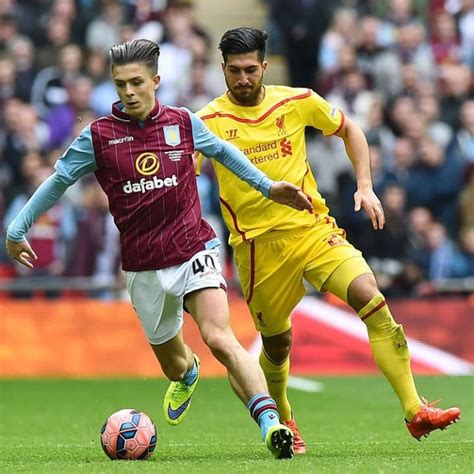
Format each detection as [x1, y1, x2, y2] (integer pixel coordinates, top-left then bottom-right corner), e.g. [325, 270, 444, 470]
[222, 51, 267, 105]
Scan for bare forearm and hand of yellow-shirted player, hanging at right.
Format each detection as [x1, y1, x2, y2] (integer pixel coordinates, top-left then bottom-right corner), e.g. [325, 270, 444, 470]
[336, 117, 385, 230]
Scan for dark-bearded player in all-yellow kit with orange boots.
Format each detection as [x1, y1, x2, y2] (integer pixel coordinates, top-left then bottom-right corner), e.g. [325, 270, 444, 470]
[197, 27, 460, 453]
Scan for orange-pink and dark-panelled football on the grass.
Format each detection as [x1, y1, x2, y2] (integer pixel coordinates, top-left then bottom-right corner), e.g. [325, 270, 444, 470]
[100, 408, 157, 459]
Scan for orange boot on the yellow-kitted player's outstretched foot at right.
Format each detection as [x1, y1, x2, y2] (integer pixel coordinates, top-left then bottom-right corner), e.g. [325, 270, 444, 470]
[405, 397, 461, 441]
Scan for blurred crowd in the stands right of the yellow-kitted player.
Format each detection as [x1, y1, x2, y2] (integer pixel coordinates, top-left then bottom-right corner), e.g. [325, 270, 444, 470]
[266, 0, 474, 296]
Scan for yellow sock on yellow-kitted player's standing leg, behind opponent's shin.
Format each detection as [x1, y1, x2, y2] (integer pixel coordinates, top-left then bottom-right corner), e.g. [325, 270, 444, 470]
[259, 347, 291, 421]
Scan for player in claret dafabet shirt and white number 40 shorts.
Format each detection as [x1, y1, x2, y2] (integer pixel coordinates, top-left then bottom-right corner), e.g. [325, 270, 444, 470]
[7, 40, 318, 458]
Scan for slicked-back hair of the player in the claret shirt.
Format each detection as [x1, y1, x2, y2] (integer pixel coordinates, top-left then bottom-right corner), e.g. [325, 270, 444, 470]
[109, 39, 160, 74]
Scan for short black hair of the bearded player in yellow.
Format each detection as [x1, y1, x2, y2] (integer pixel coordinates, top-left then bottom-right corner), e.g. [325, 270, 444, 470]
[219, 26, 268, 62]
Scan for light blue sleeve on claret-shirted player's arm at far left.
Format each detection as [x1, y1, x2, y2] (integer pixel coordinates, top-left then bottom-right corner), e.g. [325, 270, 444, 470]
[7, 127, 97, 242]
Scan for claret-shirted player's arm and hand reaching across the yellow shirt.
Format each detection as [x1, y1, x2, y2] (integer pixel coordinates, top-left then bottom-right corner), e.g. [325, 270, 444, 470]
[189, 109, 313, 212]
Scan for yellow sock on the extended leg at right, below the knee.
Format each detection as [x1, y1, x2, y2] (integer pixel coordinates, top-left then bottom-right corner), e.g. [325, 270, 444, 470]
[359, 293, 422, 421]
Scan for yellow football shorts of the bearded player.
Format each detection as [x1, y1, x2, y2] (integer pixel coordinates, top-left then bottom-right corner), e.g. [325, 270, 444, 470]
[234, 217, 372, 337]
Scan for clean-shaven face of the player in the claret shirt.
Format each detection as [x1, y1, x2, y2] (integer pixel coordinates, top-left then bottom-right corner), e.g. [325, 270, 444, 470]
[112, 63, 160, 120]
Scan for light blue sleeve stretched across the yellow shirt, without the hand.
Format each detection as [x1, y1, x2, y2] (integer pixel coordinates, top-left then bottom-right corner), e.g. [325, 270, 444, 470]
[188, 111, 274, 197]
